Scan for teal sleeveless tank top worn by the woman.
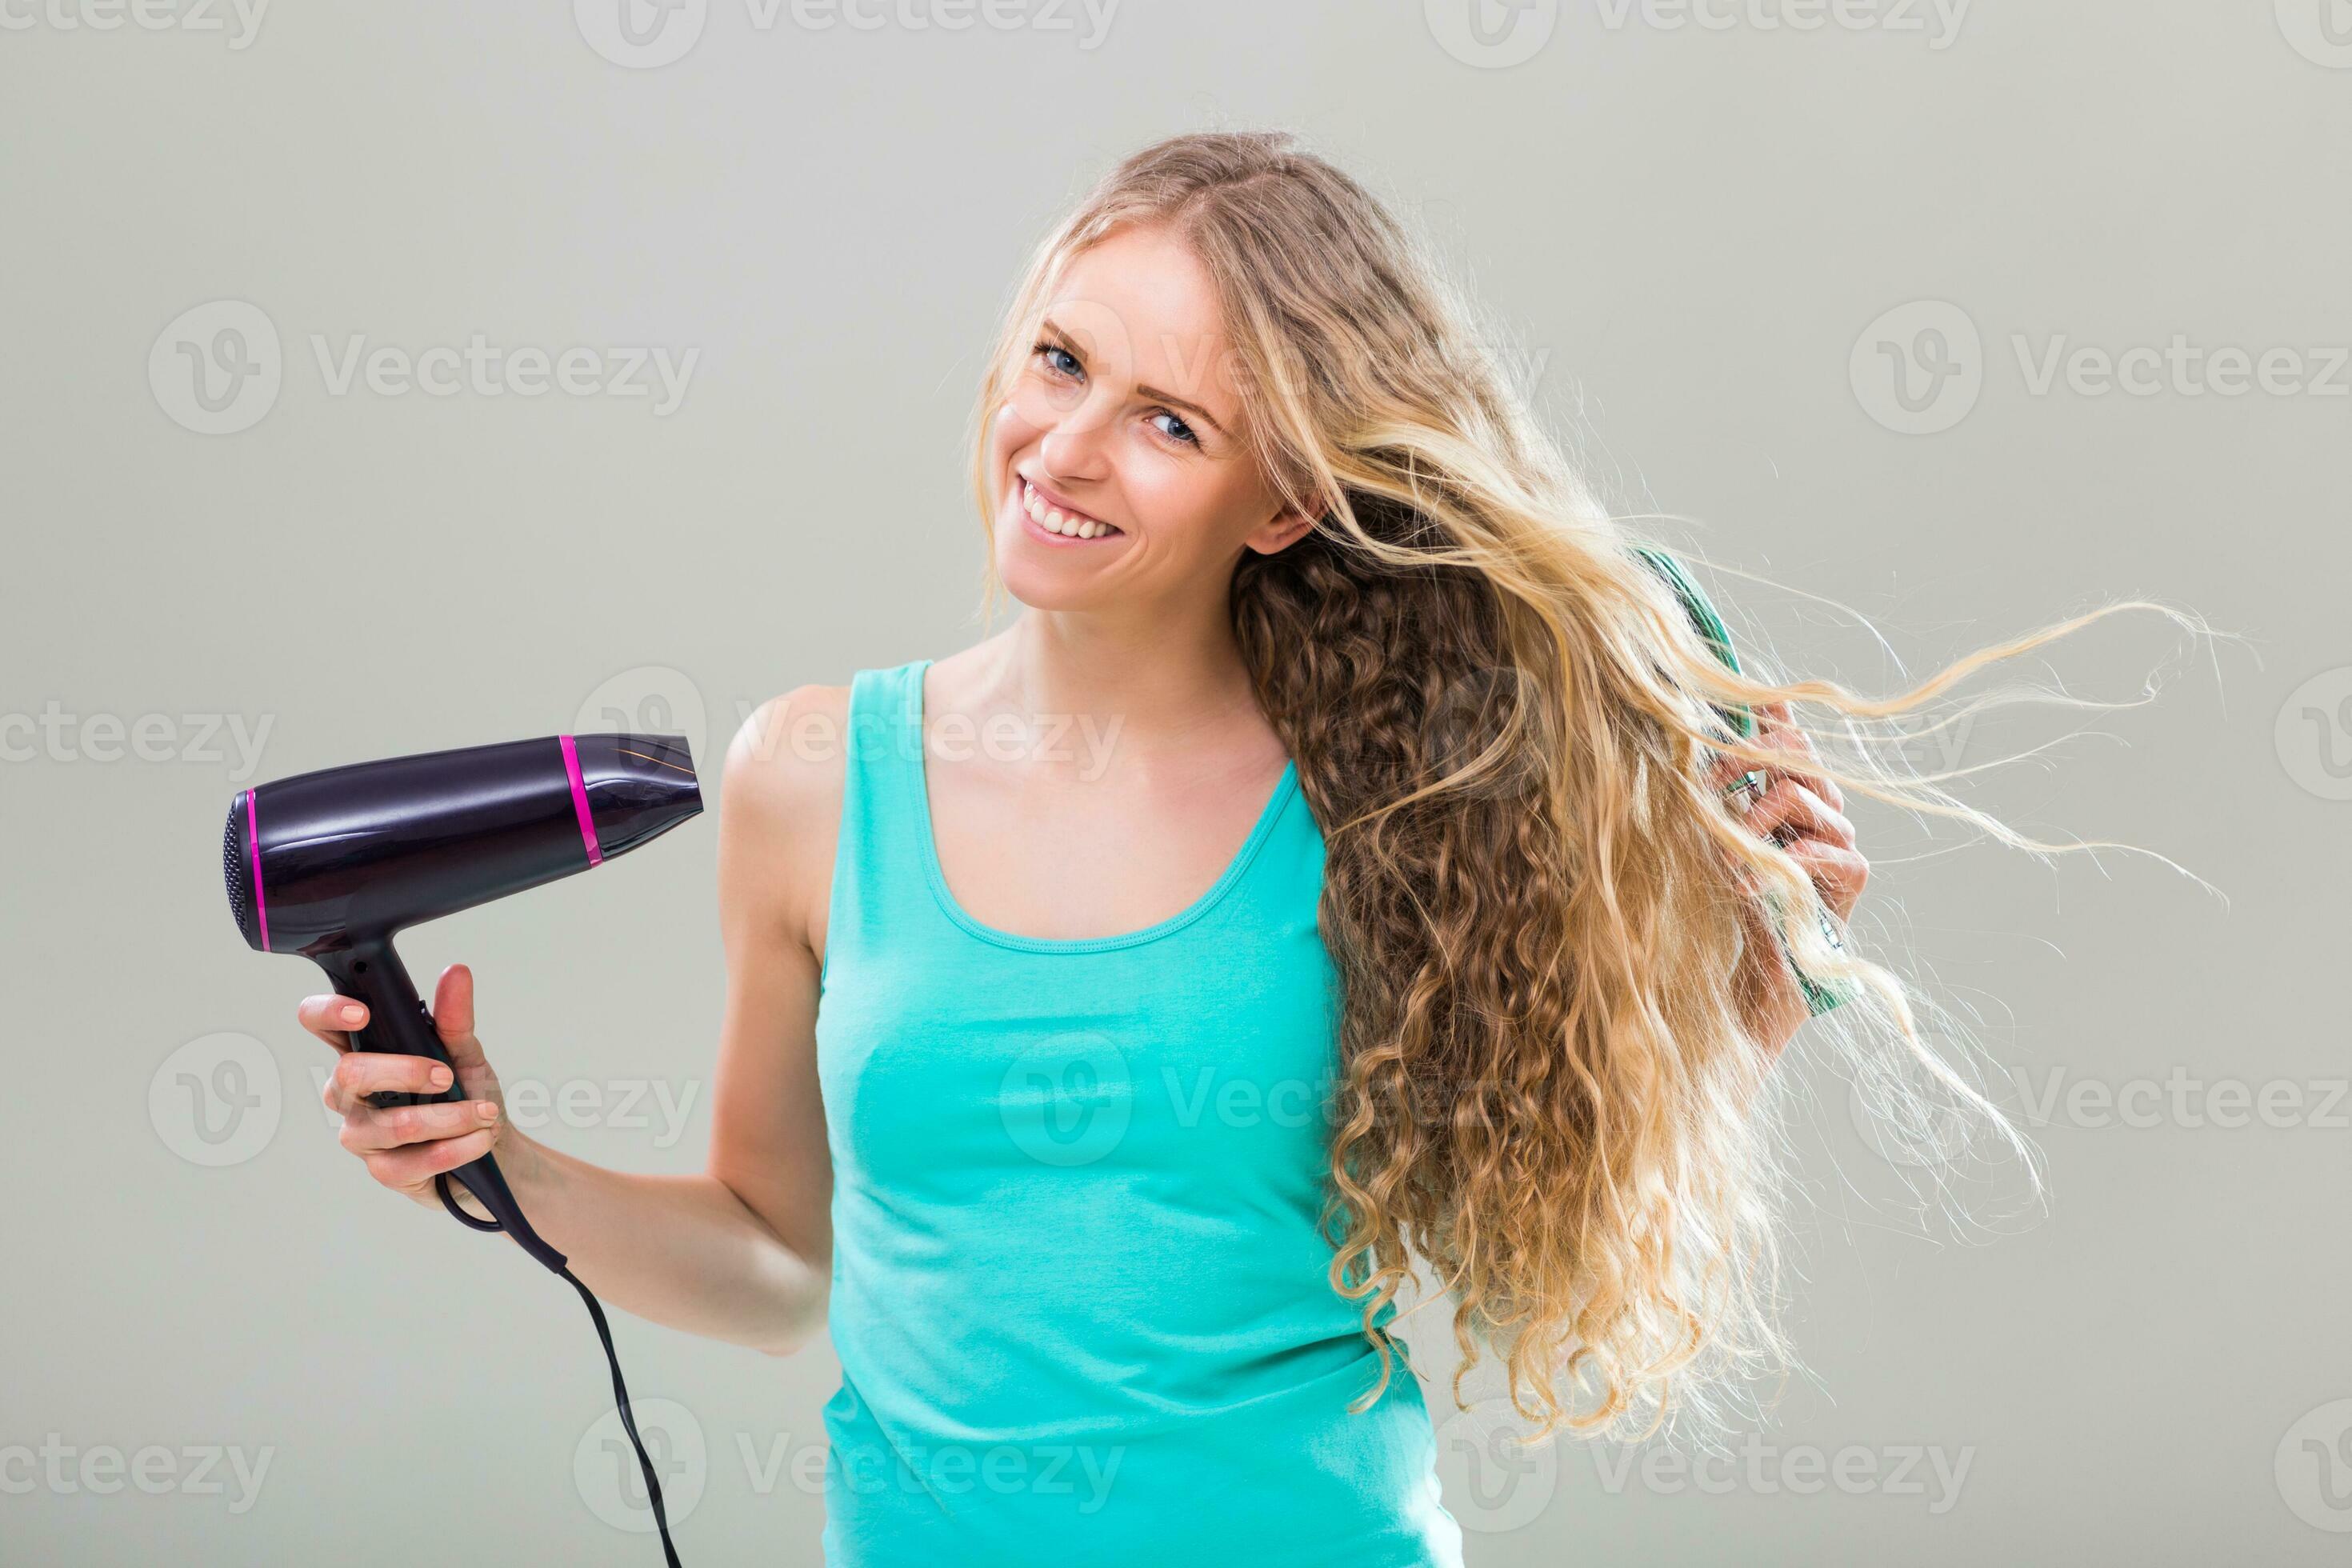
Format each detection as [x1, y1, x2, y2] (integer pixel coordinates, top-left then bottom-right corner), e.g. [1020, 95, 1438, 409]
[816, 658, 1461, 1568]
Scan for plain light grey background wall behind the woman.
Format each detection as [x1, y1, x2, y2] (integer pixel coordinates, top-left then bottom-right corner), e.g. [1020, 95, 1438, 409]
[0, 0, 2352, 1566]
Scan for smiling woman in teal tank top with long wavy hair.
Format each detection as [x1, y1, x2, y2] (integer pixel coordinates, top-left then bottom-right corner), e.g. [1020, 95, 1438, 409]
[301, 134, 2135, 1568]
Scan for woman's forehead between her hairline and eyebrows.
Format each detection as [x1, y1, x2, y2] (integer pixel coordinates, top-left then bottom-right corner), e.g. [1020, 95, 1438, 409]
[1044, 226, 1233, 416]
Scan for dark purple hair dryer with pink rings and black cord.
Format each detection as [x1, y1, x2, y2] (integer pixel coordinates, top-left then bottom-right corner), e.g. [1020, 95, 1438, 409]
[221, 734, 703, 1566]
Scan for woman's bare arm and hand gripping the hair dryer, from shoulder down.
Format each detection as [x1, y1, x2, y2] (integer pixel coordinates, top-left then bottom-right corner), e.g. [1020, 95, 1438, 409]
[301, 686, 844, 1354]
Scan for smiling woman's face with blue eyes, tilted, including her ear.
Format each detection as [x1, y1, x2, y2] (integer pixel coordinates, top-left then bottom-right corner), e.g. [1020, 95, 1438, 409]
[990, 226, 1308, 609]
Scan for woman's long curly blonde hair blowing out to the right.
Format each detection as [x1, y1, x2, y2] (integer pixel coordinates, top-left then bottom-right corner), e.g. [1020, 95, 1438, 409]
[971, 134, 2202, 1438]
